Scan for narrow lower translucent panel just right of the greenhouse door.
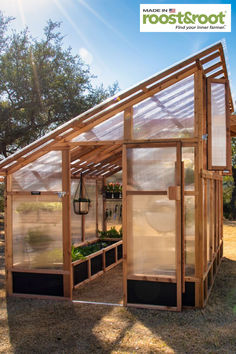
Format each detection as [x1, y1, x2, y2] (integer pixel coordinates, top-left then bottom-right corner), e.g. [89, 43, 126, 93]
[184, 196, 195, 275]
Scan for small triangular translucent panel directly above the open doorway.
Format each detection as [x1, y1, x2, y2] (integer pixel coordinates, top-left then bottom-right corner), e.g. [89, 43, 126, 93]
[72, 112, 124, 141]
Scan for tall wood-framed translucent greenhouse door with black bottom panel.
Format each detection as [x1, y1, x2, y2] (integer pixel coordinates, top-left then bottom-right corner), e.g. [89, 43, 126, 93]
[123, 143, 183, 311]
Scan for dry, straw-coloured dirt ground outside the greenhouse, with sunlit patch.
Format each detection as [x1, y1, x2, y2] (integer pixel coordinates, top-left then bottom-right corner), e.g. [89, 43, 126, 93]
[0, 222, 236, 354]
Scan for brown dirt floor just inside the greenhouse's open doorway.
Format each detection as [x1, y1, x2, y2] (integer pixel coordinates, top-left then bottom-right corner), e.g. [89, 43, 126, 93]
[73, 263, 123, 304]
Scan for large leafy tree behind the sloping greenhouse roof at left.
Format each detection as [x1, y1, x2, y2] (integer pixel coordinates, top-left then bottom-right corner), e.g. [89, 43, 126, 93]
[0, 13, 118, 158]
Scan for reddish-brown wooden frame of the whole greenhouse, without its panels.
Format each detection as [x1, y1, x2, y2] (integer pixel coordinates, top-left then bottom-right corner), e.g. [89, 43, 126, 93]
[0, 43, 233, 311]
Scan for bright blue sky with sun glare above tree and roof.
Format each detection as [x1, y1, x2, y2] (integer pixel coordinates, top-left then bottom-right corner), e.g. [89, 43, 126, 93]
[0, 0, 236, 103]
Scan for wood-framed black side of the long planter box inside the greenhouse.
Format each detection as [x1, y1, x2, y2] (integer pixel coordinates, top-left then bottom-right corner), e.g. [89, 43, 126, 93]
[72, 240, 123, 289]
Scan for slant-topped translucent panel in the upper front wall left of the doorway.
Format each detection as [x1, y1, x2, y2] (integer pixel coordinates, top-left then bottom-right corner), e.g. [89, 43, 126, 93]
[12, 151, 62, 191]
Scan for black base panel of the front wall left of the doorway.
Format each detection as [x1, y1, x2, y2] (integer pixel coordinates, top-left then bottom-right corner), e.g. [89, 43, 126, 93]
[12, 272, 64, 296]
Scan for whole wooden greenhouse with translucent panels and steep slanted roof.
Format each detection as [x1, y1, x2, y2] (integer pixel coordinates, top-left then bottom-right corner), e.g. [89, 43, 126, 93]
[0, 43, 236, 311]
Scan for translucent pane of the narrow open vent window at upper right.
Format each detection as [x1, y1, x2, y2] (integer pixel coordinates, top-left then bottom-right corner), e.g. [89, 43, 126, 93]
[211, 83, 227, 166]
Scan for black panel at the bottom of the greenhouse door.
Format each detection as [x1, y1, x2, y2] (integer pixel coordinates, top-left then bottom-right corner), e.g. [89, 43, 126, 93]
[127, 280, 177, 307]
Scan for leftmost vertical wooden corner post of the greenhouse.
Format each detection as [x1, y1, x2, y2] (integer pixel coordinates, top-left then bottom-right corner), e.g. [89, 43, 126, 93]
[4, 175, 13, 296]
